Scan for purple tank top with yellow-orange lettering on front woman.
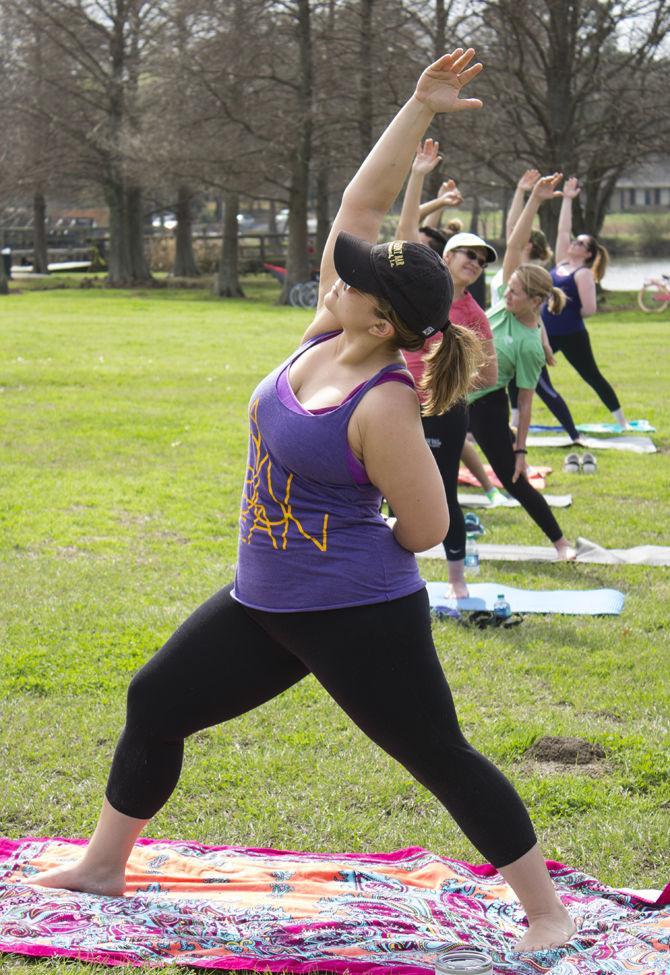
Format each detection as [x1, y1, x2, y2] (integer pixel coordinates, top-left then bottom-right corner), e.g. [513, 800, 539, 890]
[232, 332, 423, 613]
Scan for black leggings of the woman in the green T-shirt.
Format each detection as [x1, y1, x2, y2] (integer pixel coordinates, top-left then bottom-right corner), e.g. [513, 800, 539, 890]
[470, 389, 563, 542]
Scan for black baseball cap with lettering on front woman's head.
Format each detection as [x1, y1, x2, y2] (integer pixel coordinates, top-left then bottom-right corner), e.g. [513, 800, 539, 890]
[334, 231, 454, 338]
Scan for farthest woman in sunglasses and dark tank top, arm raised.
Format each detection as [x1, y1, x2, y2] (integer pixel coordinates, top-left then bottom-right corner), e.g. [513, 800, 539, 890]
[542, 176, 626, 427]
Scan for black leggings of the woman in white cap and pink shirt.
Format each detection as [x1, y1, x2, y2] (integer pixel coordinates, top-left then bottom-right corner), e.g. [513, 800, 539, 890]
[421, 402, 468, 562]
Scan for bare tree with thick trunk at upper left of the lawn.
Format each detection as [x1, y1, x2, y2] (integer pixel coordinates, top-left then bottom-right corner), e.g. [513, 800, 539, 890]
[15, 0, 165, 284]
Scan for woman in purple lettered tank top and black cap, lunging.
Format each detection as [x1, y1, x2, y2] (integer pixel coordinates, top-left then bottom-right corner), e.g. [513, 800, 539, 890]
[34, 48, 574, 950]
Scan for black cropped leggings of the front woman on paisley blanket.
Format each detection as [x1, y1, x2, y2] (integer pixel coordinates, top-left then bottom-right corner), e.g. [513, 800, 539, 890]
[107, 580, 536, 866]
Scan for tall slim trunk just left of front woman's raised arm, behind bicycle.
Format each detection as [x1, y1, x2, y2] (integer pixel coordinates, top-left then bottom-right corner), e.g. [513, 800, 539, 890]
[279, 0, 313, 305]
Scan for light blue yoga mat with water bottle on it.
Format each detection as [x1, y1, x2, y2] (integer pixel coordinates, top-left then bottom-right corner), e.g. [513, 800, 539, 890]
[426, 582, 625, 616]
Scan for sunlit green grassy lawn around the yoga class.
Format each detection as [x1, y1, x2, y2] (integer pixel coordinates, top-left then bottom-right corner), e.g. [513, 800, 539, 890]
[0, 283, 670, 975]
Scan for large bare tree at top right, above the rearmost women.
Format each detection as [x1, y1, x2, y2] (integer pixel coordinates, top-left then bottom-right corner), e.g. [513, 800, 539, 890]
[473, 0, 670, 239]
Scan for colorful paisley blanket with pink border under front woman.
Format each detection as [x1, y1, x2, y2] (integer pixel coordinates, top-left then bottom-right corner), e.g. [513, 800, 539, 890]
[0, 839, 670, 975]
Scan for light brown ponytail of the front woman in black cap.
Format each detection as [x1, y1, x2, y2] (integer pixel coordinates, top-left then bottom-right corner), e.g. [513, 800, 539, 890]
[419, 325, 484, 416]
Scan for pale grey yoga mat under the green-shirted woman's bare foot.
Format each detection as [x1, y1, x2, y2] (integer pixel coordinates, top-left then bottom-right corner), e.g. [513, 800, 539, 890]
[418, 538, 670, 565]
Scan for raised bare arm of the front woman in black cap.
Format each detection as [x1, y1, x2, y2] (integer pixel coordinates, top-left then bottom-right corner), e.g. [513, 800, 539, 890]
[312, 47, 482, 316]
